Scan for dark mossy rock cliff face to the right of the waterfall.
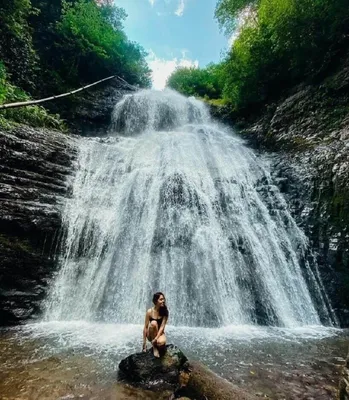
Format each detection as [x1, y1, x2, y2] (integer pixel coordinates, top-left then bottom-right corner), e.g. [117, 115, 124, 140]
[237, 58, 349, 326]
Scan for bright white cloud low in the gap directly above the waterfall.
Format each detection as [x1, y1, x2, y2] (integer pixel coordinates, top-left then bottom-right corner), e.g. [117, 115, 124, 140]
[147, 50, 199, 90]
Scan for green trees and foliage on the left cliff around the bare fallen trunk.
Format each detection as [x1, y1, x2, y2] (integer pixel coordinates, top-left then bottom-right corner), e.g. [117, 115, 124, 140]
[0, 0, 151, 125]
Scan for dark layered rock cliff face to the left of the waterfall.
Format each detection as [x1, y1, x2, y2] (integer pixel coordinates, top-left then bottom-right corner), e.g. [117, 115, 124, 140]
[0, 126, 77, 326]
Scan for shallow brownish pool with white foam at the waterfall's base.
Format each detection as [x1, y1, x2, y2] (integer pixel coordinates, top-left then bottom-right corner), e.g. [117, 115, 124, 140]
[0, 321, 349, 400]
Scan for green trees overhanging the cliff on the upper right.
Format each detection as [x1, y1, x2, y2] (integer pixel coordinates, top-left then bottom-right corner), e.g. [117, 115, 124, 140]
[168, 0, 349, 111]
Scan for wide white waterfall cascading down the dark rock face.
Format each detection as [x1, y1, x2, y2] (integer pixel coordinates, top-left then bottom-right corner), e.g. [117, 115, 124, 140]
[46, 91, 332, 327]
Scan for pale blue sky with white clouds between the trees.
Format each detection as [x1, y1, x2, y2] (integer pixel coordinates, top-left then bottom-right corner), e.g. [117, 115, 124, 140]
[115, 0, 228, 89]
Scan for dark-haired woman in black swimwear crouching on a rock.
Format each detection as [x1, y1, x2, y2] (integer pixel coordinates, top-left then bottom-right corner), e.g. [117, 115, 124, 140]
[143, 292, 168, 357]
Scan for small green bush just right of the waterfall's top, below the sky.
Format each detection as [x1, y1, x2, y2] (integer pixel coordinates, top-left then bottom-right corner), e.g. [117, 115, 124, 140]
[167, 64, 223, 99]
